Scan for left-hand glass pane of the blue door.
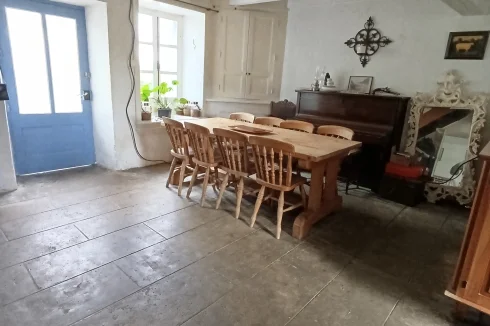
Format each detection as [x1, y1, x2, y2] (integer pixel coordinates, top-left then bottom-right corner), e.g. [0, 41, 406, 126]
[6, 8, 51, 114]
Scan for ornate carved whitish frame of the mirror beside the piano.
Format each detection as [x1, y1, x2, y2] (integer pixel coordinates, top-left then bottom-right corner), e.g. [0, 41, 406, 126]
[405, 71, 488, 205]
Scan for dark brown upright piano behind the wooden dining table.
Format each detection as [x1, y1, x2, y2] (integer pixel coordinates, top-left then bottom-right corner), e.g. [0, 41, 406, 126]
[273, 90, 410, 191]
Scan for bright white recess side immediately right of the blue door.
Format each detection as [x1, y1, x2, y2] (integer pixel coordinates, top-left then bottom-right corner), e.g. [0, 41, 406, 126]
[85, 2, 116, 168]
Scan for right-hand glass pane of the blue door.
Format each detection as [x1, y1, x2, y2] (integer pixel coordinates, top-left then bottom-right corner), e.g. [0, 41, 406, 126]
[46, 15, 83, 113]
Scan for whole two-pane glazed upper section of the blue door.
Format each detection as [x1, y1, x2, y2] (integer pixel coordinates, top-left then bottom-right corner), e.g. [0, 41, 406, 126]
[6, 8, 83, 114]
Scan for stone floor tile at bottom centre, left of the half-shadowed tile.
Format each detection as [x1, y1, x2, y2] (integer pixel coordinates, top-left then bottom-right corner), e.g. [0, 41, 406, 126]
[184, 262, 323, 326]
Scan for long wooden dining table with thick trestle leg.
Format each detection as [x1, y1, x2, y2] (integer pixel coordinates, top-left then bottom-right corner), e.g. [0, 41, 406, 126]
[178, 118, 361, 239]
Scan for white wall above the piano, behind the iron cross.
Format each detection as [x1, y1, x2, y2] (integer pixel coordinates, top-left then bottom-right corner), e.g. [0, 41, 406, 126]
[281, 0, 490, 145]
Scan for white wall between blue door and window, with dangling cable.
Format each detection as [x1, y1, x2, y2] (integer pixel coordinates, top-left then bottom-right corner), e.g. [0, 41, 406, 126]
[107, 0, 170, 170]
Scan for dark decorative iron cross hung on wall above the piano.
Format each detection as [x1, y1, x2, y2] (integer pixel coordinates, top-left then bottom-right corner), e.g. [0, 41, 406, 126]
[345, 17, 393, 67]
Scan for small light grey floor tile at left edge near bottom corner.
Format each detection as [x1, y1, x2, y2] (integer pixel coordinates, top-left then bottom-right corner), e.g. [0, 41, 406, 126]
[0, 264, 37, 307]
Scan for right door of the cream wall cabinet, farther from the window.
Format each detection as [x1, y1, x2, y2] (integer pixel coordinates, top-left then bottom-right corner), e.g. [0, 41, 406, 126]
[245, 12, 277, 99]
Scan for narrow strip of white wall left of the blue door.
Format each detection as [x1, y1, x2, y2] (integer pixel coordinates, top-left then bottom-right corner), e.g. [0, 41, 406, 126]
[0, 101, 17, 193]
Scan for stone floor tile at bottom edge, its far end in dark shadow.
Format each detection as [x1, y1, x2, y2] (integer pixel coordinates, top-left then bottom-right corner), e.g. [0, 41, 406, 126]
[288, 264, 403, 326]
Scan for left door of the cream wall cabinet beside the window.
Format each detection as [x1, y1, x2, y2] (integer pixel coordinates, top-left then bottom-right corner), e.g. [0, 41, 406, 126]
[219, 10, 249, 98]
